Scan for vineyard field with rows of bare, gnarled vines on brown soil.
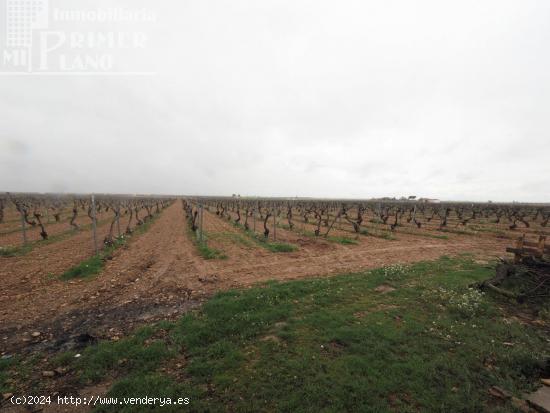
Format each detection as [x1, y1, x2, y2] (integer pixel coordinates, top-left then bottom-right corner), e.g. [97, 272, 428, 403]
[0, 195, 549, 346]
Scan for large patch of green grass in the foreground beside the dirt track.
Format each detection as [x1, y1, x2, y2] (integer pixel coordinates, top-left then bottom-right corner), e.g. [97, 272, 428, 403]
[35, 257, 548, 412]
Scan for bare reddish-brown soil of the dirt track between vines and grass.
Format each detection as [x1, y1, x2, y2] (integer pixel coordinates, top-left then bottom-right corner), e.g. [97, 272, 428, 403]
[0, 202, 509, 353]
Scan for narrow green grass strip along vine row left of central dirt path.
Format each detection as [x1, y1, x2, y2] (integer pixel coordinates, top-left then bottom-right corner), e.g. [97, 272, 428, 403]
[60, 214, 164, 280]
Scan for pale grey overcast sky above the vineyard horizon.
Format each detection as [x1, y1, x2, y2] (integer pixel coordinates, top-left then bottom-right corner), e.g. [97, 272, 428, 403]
[0, 0, 550, 202]
